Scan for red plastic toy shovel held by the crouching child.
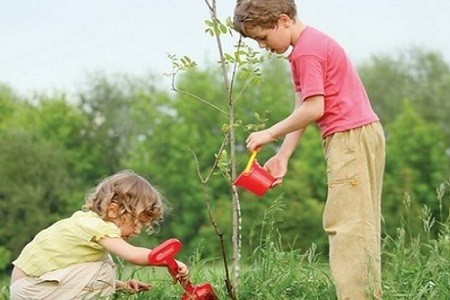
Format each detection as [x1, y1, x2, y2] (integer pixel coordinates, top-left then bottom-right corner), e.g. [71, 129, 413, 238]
[148, 238, 217, 300]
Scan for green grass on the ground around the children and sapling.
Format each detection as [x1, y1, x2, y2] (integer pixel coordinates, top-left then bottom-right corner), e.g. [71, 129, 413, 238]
[0, 182, 450, 300]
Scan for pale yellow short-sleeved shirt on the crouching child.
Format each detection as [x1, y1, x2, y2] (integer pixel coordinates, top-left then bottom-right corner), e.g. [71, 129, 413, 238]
[13, 211, 120, 277]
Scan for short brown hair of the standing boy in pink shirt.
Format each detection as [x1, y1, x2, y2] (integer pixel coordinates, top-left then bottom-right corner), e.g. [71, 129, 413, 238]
[233, 0, 297, 37]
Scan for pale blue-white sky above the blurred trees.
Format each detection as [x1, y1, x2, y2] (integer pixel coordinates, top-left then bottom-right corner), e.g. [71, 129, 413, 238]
[0, 0, 450, 95]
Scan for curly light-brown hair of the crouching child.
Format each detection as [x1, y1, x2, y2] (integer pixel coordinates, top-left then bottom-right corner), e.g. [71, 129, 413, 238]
[83, 170, 167, 234]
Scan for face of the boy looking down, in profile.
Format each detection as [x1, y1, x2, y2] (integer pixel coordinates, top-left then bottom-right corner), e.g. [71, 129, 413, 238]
[245, 18, 292, 54]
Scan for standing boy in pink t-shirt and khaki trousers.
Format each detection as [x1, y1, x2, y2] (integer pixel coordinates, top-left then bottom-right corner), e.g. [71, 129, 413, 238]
[234, 0, 385, 299]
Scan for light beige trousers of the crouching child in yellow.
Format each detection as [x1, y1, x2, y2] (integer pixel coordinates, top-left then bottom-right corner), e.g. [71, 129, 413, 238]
[9, 262, 115, 300]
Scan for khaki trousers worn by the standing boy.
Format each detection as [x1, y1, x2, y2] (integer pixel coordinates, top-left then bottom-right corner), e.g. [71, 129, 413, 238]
[323, 122, 385, 300]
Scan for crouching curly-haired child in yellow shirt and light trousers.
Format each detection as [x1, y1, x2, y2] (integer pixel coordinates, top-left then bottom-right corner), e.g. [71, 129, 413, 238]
[10, 171, 188, 300]
